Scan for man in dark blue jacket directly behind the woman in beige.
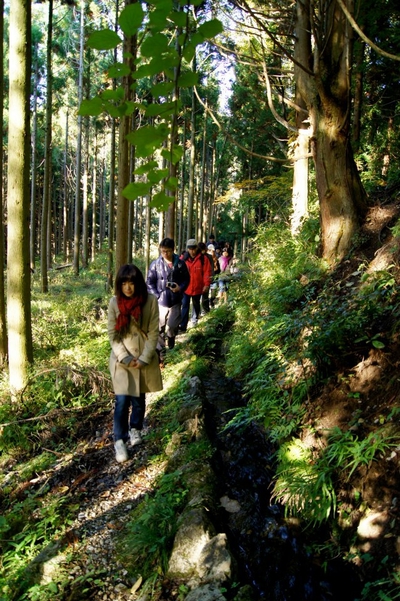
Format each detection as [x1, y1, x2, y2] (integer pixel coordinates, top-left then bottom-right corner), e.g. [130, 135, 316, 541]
[146, 238, 190, 367]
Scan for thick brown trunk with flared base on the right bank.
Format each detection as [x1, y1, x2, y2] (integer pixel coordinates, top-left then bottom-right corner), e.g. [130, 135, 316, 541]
[296, 0, 366, 263]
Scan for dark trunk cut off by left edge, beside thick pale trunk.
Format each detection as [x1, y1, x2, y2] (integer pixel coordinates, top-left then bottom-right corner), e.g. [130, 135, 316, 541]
[0, 0, 8, 366]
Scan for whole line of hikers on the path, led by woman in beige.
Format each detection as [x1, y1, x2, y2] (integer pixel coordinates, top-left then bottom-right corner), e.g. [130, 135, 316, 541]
[108, 235, 233, 463]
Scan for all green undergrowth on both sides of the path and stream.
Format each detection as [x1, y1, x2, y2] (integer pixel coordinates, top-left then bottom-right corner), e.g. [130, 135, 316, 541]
[0, 219, 400, 601]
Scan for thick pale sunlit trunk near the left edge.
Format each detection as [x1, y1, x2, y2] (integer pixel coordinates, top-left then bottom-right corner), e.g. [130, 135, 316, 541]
[7, 0, 33, 397]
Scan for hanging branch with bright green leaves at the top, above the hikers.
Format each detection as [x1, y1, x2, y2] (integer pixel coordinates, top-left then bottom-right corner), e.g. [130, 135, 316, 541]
[79, 0, 223, 210]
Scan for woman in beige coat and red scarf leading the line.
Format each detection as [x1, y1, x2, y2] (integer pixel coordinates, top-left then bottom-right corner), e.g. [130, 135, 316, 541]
[108, 264, 162, 462]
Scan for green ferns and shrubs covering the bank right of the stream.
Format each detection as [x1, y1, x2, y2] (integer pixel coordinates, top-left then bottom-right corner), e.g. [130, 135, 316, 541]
[222, 220, 400, 599]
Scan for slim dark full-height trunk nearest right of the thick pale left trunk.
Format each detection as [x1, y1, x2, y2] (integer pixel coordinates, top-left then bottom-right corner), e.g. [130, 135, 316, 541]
[40, 0, 53, 292]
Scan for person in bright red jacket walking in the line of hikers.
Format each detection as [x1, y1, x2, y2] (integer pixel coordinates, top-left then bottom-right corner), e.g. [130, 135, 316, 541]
[179, 238, 212, 332]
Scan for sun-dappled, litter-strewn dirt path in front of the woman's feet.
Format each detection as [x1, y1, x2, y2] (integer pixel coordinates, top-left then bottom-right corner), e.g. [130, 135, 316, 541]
[1, 400, 164, 598]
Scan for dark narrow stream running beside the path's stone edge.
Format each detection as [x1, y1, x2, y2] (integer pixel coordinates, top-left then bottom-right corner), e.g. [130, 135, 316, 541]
[203, 371, 361, 601]
